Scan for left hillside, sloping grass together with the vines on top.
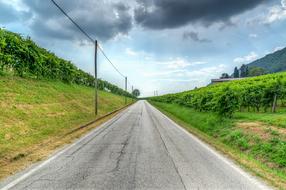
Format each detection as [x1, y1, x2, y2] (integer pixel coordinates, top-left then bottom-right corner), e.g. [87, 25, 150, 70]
[0, 29, 134, 179]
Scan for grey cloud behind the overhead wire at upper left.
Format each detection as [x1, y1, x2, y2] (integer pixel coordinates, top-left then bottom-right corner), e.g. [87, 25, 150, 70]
[24, 0, 132, 41]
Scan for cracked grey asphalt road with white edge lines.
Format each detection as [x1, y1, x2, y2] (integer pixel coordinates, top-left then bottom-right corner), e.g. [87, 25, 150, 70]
[0, 101, 268, 190]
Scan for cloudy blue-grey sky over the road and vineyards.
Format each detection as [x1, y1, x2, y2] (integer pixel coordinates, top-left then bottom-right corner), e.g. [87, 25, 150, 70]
[0, 0, 286, 96]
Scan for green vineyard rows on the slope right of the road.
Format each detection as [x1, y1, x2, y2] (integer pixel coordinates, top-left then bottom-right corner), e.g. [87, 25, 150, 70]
[150, 73, 286, 117]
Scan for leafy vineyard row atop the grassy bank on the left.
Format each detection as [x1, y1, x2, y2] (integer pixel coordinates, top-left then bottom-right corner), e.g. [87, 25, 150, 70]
[0, 29, 132, 97]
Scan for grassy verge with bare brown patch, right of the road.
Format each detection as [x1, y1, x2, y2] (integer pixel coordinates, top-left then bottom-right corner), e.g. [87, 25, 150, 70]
[151, 102, 286, 189]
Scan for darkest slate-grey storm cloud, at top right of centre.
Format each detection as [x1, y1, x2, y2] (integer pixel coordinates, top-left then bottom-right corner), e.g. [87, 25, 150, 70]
[134, 0, 266, 29]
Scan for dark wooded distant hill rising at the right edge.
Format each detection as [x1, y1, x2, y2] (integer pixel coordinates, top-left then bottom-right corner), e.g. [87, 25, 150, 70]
[247, 48, 286, 73]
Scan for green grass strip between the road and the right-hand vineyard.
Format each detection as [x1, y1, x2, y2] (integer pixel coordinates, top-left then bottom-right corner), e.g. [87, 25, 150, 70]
[151, 101, 286, 188]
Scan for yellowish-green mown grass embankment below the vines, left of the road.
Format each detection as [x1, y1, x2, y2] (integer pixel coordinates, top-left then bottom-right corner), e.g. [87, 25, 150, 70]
[0, 76, 131, 179]
